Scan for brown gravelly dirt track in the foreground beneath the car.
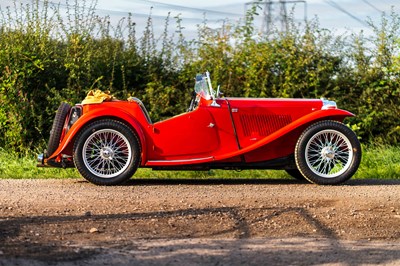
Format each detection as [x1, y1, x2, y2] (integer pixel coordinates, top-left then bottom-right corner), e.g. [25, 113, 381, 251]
[0, 179, 400, 265]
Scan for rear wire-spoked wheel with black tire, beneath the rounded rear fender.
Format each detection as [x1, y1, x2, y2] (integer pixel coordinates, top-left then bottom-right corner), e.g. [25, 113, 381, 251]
[73, 119, 141, 185]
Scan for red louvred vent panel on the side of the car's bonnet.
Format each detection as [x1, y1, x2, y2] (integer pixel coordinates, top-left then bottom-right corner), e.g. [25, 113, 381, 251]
[240, 114, 292, 137]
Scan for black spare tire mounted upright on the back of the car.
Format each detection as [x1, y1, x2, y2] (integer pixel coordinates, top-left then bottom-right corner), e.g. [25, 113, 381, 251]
[46, 103, 71, 156]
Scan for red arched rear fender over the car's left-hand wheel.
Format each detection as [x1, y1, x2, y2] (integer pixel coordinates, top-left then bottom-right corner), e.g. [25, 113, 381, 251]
[47, 107, 146, 162]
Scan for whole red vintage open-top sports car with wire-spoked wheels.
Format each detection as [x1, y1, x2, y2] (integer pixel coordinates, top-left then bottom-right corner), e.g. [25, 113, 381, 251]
[38, 72, 361, 185]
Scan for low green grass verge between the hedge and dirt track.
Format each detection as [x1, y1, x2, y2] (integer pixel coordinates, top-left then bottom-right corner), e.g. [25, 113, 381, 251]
[0, 146, 400, 179]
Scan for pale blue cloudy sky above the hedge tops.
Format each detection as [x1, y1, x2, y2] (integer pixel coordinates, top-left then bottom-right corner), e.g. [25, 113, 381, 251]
[0, 0, 400, 38]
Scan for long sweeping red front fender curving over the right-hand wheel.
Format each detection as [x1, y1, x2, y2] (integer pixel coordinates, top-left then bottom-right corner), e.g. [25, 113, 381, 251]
[214, 109, 354, 160]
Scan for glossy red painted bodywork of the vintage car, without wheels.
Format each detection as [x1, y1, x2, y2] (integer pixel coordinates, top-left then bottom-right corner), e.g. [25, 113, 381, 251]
[46, 94, 353, 167]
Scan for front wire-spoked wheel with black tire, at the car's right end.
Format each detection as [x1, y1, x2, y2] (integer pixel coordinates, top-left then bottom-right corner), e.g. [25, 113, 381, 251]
[295, 120, 361, 185]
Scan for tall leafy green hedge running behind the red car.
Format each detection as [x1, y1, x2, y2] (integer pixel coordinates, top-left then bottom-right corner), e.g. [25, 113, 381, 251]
[0, 0, 400, 152]
